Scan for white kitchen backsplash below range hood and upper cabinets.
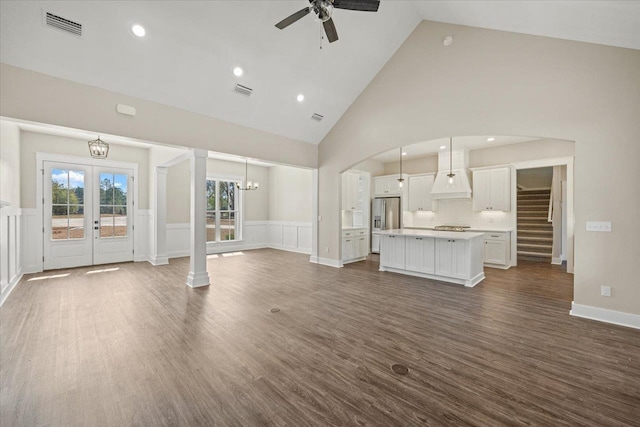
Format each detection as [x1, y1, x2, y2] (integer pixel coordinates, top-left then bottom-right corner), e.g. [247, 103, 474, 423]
[403, 199, 512, 229]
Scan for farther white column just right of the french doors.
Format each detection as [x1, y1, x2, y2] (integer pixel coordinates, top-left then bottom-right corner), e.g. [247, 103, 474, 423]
[150, 166, 169, 265]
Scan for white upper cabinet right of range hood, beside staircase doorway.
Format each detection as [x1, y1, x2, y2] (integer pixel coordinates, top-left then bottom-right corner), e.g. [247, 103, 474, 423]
[473, 166, 511, 211]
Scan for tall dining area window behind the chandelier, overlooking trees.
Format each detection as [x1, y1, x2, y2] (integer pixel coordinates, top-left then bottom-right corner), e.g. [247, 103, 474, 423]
[206, 179, 240, 242]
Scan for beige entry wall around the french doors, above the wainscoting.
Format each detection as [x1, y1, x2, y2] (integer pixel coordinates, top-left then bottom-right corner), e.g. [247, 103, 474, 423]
[20, 131, 149, 209]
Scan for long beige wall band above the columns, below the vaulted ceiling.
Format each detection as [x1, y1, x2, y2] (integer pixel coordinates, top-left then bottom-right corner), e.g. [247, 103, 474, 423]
[0, 64, 318, 168]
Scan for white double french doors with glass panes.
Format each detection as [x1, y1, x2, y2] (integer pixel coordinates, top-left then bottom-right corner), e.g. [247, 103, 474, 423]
[43, 161, 133, 270]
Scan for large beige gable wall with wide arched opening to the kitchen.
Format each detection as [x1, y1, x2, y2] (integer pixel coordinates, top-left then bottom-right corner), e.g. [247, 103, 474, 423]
[318, 21, 640, 315]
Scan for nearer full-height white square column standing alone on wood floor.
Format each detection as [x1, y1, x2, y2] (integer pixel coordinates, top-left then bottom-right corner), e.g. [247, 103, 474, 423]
[187, 150, 209, 288]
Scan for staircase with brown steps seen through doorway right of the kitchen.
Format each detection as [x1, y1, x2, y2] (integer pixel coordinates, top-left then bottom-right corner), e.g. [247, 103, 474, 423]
[518, 190, 553, 263]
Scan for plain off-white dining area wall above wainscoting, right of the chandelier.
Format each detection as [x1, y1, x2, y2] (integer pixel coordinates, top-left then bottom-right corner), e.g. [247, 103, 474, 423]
[269, 166, 313, 222]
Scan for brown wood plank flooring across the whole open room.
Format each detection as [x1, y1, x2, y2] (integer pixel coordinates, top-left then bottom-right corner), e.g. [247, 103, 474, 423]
[0, 249, 640, 426]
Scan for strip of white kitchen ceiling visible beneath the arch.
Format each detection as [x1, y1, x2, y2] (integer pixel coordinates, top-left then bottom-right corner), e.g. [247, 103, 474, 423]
[372, 135, 540, 163]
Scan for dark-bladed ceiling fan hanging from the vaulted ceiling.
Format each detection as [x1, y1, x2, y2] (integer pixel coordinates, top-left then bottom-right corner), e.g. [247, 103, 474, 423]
[276, 0, 380, 43]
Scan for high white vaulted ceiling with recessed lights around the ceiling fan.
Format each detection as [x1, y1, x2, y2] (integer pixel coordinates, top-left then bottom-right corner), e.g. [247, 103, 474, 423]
[0, 0, 640, 144]
